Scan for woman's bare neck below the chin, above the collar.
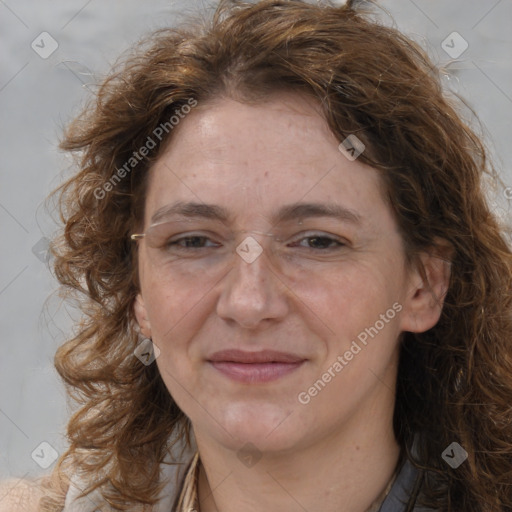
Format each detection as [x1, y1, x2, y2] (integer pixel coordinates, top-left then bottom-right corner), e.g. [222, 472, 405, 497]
[195, 389, 400, 512]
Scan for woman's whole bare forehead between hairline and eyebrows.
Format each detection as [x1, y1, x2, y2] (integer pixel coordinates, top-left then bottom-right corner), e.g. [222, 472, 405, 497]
[142, 93, 390, 228]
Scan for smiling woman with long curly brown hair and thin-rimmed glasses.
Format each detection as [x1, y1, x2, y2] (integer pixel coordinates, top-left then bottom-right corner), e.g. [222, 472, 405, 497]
[2, 0, 512, 512]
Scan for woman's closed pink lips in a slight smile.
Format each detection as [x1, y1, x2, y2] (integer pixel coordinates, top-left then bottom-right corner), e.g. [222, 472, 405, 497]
[208, 349, 306, 383]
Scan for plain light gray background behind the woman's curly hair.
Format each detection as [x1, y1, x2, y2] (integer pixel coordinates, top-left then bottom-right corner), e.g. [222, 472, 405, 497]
[0, 0, 512, 479]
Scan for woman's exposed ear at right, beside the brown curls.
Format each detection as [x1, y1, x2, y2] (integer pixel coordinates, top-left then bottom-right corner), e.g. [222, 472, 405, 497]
[400, 242, 453, 333]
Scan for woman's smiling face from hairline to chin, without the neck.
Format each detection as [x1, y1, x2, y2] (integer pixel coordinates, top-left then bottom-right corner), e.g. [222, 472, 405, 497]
[135, 93, 437, 450]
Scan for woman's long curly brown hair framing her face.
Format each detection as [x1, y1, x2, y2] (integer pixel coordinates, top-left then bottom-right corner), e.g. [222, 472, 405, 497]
[41, 0, 512, 512]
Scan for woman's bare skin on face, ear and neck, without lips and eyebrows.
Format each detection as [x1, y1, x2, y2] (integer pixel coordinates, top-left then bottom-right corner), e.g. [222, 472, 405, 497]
[135, 93, 449, 512]
